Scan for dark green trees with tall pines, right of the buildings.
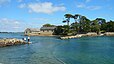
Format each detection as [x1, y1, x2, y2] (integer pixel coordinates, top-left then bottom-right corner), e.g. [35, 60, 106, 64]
[54, 14, 114, 35]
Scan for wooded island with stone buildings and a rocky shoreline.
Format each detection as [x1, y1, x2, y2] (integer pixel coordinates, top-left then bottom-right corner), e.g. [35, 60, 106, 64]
[24, 14, 114, 39]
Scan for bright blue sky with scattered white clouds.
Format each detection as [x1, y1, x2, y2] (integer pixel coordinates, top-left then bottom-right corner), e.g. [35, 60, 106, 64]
[0, 0, 114, 32]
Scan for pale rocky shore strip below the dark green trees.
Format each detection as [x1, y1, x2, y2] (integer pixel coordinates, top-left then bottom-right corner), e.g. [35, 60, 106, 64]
[60, 32, 114, 39]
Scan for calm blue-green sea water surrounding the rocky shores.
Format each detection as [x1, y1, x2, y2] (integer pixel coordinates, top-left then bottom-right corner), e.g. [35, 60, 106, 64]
[0, 33, 114, 64]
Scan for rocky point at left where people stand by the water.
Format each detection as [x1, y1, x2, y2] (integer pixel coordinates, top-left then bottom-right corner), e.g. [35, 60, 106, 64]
[0, 38, 27, 47]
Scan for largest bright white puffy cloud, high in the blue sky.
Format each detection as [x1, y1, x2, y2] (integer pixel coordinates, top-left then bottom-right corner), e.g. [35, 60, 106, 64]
[20, 2, 66, 14]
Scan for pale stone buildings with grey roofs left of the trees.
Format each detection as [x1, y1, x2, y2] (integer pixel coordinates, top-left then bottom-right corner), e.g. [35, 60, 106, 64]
[24, 26, 56, 36]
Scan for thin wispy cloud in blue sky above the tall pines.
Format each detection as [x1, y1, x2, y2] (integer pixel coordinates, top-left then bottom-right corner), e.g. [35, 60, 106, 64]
[77, 3, 102, 10]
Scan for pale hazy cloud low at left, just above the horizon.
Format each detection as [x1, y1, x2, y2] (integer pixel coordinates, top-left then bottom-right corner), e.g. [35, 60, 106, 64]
[0, 18, 22, 31]
